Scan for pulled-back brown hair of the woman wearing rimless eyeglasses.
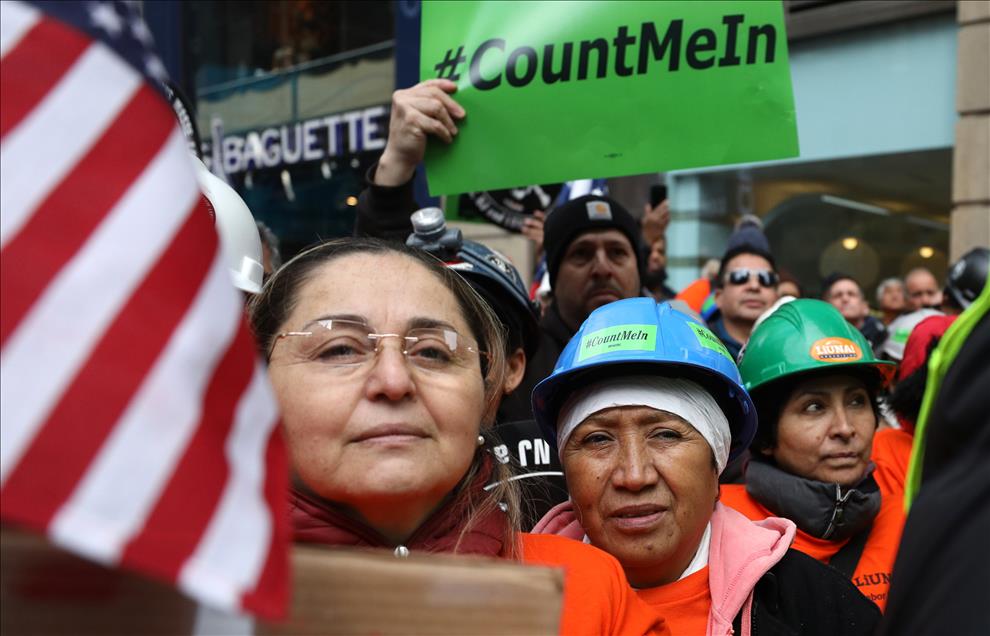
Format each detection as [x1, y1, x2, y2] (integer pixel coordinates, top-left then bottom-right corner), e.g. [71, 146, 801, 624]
[248, 238, 520, 556]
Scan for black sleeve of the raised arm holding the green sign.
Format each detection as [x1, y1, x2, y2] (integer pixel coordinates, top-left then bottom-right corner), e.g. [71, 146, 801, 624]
[354, 162, 419, 243]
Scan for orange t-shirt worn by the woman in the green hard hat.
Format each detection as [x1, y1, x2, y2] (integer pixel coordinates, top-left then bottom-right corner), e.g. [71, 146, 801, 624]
[719, 484, 904, 611]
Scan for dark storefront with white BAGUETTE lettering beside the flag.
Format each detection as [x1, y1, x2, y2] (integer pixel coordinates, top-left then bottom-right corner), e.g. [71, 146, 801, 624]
[183, 0, 395, 258]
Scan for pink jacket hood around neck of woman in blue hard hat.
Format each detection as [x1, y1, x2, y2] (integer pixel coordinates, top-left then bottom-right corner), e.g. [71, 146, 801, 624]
[533, 501, 795, 636]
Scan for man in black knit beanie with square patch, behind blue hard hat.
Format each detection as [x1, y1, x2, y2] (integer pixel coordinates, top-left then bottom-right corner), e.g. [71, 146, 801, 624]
[520, 194, 646, 412]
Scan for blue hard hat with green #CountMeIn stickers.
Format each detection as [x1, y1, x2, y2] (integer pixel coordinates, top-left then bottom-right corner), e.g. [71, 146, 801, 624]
[533, 298, 756, 460]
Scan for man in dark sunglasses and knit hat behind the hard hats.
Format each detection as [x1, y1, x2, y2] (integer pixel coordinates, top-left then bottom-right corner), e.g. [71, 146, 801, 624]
[708, 246, 780, 358]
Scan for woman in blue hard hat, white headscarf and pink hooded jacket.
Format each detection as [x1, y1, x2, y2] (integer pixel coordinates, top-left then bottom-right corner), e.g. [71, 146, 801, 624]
[533, 298, 880, 635]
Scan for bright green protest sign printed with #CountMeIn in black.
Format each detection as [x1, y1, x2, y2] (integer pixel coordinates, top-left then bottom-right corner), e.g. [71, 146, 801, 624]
[420, 1, 798, 195]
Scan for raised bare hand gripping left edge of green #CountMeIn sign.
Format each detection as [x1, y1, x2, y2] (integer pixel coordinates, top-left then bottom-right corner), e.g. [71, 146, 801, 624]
[374, 79, 466, 186]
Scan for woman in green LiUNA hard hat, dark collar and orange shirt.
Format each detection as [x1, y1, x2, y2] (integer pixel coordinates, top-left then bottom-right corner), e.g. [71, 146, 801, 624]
[722, 299, 904, 610]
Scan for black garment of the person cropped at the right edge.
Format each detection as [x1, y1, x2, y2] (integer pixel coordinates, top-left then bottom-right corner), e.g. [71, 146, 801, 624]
[881, 313, 990, 636]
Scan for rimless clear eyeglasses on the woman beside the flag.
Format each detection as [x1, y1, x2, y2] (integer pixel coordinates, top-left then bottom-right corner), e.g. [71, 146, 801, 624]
[268, 319, 487, 373]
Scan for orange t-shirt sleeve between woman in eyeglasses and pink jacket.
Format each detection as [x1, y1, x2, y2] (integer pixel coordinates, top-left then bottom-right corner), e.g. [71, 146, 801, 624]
[519, 533, 670, 636]
